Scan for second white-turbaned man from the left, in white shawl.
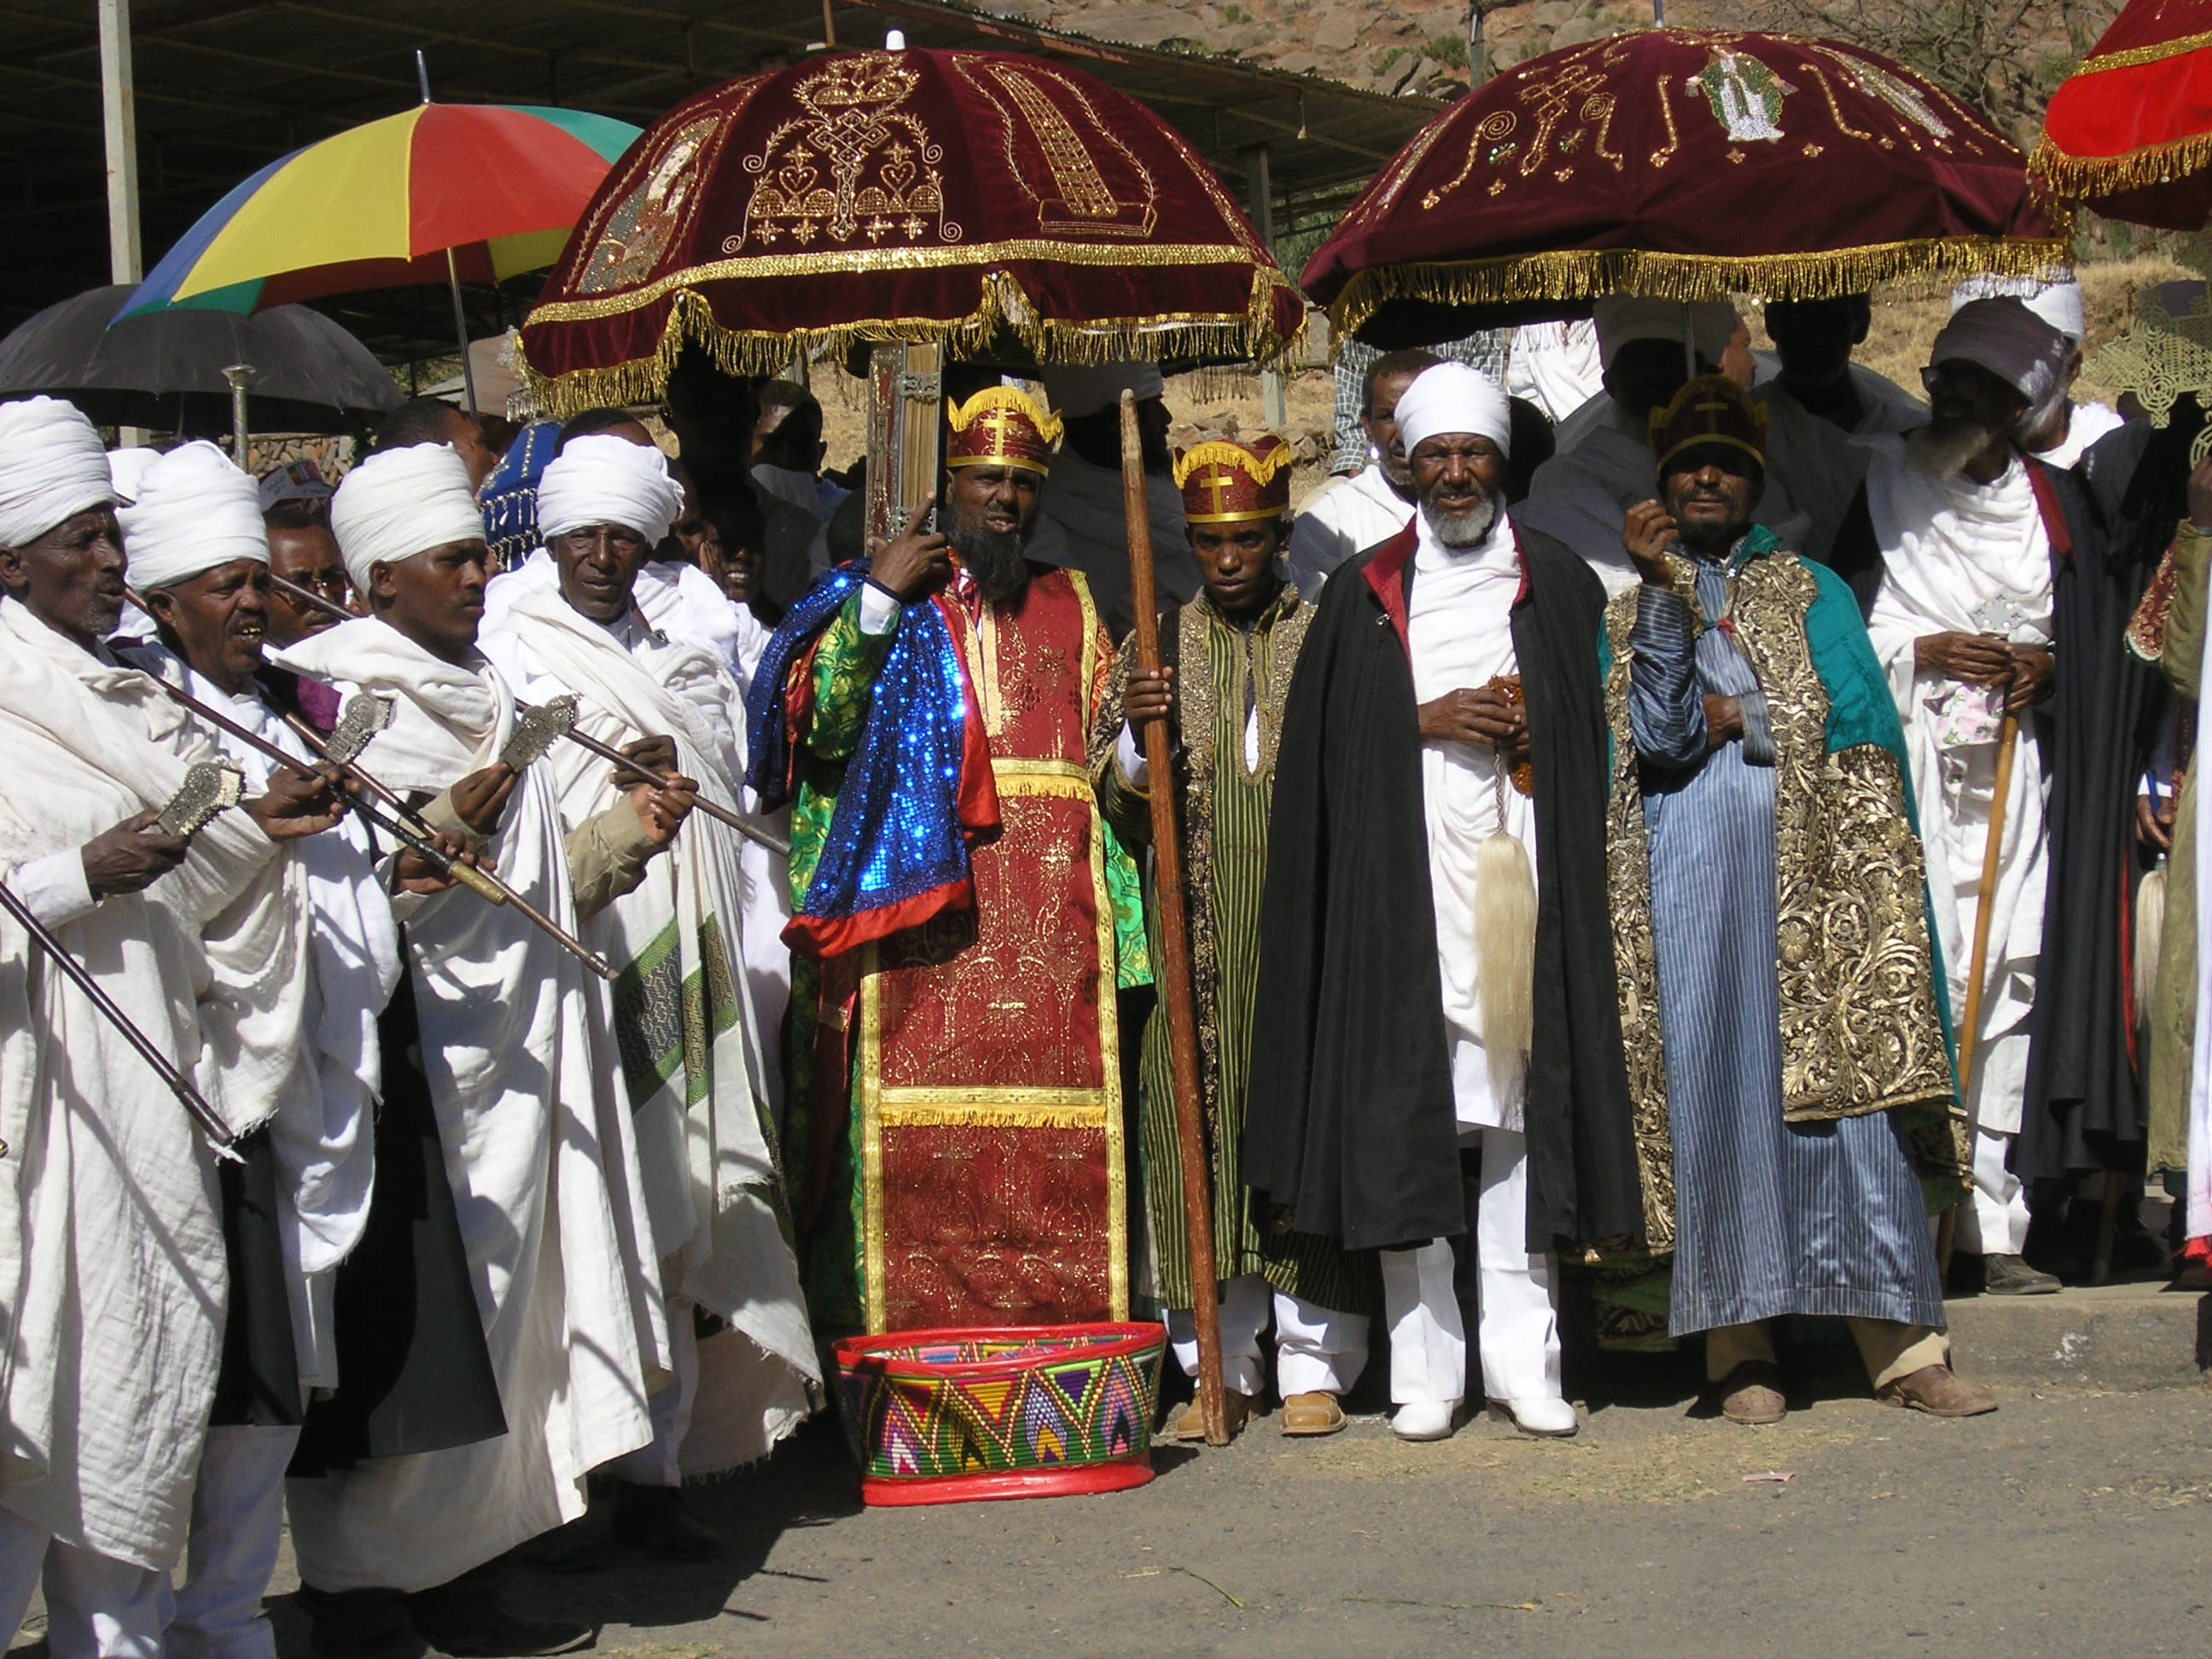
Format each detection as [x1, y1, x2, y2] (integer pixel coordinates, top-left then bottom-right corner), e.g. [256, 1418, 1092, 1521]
[119, 442, 399, 1659]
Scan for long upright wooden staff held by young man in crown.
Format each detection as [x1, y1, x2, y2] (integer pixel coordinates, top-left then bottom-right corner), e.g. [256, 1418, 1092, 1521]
[1121, 392, 1230, 1447]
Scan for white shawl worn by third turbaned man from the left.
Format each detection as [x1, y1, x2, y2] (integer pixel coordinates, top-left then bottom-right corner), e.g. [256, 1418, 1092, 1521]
[279, 617, 668, 1591]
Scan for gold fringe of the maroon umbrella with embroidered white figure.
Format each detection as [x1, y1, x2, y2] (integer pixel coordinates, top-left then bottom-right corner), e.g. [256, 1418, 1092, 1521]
[1330, 234, 2073, 334]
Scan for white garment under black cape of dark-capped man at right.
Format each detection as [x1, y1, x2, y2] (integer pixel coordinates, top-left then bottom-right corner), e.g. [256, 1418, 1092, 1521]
[1867, 449, 2052, 1135]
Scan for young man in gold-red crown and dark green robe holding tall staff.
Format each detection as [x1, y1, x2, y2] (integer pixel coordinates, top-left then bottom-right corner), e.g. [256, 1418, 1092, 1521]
[1092, 434, 1374, 1440]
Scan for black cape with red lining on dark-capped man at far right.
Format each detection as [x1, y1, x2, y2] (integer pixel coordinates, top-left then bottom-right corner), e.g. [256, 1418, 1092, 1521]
[1831, 458, 2170, 1181]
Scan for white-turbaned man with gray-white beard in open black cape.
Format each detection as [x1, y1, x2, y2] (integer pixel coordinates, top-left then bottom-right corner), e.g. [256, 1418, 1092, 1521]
[1243, 363, 1650, 1440]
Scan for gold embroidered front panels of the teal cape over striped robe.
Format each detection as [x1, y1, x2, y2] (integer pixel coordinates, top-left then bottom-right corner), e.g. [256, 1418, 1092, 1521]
[1606, 553, 1970, 1252]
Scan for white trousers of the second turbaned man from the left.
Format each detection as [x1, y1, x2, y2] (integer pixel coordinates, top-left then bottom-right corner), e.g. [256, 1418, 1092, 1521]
[161, 1427, 299, 1659]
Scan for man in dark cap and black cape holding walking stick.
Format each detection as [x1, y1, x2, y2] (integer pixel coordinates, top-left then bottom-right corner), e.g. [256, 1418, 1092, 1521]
[1831, 299, 2123, 1294]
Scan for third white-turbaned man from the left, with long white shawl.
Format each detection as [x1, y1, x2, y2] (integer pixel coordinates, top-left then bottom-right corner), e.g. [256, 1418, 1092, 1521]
[279, 445, 690, 1655]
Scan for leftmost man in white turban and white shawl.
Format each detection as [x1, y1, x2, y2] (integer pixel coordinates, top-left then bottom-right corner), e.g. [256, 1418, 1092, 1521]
[0, 399, 334, 1659]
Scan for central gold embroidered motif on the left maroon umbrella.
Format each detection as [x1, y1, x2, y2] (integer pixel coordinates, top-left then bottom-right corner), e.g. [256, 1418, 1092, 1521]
[721, 53, 963, 254]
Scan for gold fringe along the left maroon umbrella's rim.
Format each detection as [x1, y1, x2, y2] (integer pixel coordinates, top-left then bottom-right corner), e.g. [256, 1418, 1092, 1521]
[515, 270, 1305, 420]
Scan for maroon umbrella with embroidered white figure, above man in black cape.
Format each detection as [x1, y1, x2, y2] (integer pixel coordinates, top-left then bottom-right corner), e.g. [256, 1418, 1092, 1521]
[1303, 29, 2066, 343]
